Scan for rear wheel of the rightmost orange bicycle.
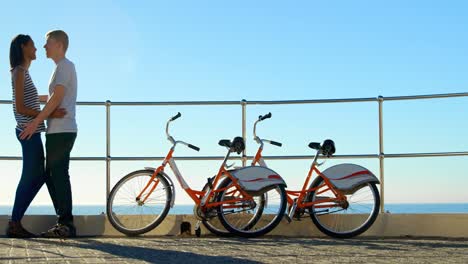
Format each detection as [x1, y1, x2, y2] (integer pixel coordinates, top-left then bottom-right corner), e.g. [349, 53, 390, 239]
[308, 177, 380, 238]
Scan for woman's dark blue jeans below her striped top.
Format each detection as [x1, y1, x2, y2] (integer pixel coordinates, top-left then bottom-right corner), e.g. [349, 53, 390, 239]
[11, 129, 45, 222]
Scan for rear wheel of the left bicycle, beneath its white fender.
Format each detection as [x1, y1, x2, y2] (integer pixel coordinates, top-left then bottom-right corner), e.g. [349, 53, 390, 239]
[216, 178, 287, 238]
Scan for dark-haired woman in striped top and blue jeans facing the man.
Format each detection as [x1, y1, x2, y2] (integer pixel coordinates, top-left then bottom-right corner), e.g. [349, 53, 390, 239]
[6, 34, 65, 238]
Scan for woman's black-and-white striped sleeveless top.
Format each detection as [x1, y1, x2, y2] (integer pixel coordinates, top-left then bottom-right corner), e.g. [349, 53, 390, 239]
[11, 66, 45, 133]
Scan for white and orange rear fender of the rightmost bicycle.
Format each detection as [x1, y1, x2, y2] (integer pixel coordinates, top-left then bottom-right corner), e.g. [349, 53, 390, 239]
[322, 163, 380, 192]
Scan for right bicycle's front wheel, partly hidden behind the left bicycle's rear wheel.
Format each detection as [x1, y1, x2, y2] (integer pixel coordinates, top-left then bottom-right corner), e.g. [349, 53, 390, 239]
[202, 178, 265, 237]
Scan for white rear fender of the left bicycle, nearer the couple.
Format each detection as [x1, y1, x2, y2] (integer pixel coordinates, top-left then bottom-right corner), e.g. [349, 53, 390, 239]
[230, 166, 286, 192]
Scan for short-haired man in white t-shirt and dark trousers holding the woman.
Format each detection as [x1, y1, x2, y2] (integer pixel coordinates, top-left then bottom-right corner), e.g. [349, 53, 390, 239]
[20, 30, 77, 238]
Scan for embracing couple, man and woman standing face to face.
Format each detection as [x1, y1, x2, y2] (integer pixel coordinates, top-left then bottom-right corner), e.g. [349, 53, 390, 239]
[6, 30, 77, 238]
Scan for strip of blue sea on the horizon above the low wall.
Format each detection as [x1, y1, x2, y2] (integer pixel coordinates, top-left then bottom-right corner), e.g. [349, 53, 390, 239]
[0, 203, 468, 215]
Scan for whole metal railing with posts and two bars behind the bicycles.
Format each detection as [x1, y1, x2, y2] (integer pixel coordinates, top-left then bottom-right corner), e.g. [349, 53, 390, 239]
[0, 93, 468, 212]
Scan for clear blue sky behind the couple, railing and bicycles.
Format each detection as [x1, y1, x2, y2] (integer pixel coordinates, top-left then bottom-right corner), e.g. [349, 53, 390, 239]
[0, 0, 468, 204]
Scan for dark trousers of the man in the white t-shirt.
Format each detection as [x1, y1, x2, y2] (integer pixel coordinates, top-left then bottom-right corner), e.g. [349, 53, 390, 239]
[46, 133, 76, 226]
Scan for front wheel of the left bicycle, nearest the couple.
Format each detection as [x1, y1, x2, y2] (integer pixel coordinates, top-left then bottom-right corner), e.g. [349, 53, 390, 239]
[107, 170, 172, 236]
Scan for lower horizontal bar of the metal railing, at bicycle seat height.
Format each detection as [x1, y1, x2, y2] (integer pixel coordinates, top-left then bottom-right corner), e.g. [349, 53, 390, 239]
[0, 151, 468, 161]
